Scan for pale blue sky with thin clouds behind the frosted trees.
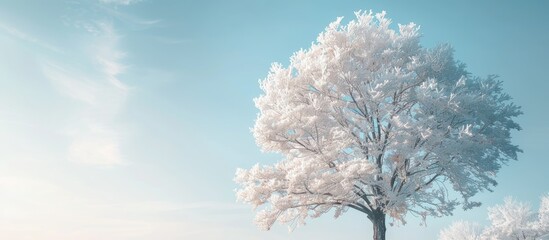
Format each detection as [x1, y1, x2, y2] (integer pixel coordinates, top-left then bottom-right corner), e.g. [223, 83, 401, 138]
[0, 0, 549, 240]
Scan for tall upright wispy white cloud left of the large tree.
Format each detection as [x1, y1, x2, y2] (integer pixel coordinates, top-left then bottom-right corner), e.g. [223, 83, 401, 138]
[43, 22, 129, 166]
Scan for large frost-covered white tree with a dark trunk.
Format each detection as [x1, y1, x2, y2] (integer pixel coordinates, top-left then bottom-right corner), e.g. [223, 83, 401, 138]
[235, 12, 521, 240]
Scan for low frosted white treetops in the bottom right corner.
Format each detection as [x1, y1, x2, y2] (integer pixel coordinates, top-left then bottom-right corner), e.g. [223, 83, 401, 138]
[439, 195, 549, 240]
